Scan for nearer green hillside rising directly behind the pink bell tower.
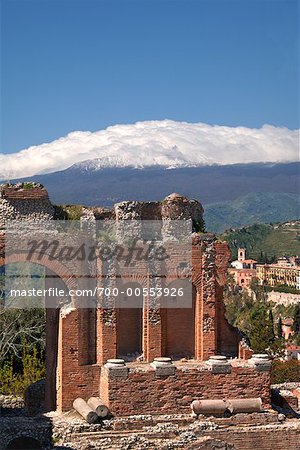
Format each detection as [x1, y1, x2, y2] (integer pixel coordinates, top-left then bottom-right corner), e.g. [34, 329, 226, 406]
[220, 221, 300, 261]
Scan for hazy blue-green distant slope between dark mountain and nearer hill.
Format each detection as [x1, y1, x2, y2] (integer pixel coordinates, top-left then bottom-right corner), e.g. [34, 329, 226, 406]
[204, 192, 300, 233]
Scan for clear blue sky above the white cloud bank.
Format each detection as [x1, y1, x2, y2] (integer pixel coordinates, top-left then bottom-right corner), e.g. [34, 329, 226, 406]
[0, 0, 299, 153]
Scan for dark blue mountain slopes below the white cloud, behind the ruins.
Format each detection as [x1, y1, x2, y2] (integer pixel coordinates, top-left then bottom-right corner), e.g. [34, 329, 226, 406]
[7, 160, 300, 231]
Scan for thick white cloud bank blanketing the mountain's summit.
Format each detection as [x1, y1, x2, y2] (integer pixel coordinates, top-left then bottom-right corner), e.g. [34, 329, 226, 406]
[0, 120, 299, 179]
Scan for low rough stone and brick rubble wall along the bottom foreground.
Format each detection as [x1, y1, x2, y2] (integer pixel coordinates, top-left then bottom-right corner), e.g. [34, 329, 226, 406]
[49, 413, 300, 450]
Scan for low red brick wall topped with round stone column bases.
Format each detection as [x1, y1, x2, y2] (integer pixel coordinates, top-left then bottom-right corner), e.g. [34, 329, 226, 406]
[100, 365, 270, 415]
